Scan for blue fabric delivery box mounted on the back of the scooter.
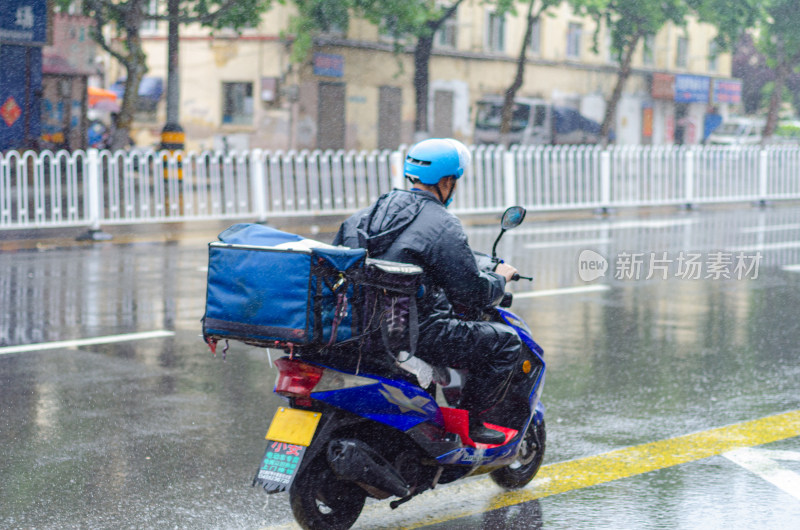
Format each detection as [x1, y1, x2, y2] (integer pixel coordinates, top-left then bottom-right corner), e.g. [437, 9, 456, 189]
[203, 224, 366, 346]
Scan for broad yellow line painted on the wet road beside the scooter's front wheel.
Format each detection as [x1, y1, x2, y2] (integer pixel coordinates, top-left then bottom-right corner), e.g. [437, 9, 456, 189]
[264, 410, 800, 528]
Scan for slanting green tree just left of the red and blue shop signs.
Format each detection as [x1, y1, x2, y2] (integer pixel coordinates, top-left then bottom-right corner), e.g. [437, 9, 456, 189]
[570, 0, 692, 144]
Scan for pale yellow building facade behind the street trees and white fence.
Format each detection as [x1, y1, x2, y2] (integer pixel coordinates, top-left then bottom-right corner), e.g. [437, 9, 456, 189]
[119, 0, 741, 150]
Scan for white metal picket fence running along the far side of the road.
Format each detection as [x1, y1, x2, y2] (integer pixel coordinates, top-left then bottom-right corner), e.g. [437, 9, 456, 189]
[0, 146, 800, 229]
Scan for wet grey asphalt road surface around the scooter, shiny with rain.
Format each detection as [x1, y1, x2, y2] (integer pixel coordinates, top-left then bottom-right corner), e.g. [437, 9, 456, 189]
[0, 206, 800, 529]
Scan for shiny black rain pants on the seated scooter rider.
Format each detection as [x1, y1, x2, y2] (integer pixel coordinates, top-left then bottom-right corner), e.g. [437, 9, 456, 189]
[417, 318, 522, 414]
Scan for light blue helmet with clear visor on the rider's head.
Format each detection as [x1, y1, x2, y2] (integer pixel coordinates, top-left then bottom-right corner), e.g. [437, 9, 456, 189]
[403, 138, 470, 186]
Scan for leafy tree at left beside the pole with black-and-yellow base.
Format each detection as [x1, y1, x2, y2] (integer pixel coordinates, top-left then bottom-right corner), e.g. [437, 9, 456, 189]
[57, 0, 270, 149]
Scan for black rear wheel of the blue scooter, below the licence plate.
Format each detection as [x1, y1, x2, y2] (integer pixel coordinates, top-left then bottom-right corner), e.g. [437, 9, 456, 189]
[289, 455, 366, 530]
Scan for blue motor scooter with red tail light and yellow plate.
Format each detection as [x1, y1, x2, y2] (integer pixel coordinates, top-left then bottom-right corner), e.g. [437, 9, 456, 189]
[253, 207, 546, 529]
